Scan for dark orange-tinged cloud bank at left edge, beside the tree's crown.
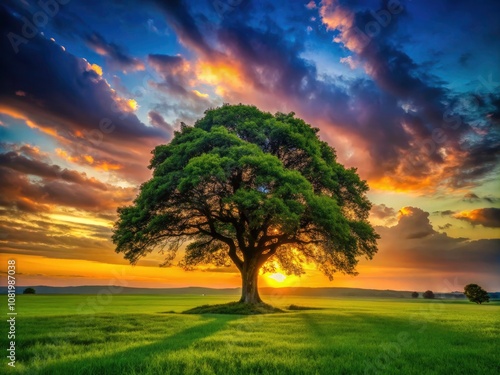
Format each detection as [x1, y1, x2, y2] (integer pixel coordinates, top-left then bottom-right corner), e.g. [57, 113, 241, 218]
[0, 145, 135, 214]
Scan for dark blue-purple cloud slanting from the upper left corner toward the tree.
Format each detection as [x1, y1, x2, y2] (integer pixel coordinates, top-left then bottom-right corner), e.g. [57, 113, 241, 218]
[0, 7, 165, 142]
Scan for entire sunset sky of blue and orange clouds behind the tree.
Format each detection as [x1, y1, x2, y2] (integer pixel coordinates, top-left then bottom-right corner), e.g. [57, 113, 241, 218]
[0, 0, 500, 292]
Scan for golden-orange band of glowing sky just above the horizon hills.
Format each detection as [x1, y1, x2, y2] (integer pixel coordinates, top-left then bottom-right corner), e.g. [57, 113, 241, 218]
[1, 254, 496, 292]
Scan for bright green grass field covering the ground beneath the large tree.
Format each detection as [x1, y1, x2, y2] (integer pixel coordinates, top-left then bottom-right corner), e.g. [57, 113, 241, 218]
[0, 295, 500, 375]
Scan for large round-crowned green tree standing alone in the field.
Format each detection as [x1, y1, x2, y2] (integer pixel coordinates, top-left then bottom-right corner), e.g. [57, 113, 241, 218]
[113, 105, 379, 303]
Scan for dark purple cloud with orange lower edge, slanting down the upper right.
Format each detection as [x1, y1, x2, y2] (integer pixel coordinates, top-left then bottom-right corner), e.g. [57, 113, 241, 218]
[320, 0, 500, 189]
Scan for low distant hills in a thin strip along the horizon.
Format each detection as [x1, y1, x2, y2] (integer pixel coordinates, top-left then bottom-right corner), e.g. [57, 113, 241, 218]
[0, 285, 500, 299]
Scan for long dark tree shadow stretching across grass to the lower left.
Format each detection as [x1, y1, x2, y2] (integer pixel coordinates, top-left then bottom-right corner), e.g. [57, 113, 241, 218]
[37, 315, 240, 375]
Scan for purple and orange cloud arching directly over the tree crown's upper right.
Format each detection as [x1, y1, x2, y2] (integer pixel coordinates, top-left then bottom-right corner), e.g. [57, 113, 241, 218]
[207, 17, 418, 187]
